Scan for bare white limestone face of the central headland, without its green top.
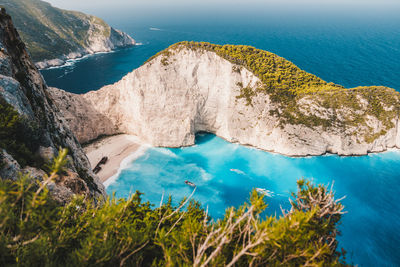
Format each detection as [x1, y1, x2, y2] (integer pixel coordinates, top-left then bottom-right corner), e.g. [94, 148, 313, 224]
[51, 48, 400, 156]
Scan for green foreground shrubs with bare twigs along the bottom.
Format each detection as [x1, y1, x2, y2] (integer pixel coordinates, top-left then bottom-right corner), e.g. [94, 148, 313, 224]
[0, 151, 344, 266]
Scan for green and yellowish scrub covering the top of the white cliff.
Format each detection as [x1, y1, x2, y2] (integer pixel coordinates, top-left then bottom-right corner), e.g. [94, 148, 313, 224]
[148, 41, 400, 143]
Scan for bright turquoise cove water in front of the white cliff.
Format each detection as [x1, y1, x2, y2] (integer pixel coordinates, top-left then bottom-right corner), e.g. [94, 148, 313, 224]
[107, 134, 400, 266]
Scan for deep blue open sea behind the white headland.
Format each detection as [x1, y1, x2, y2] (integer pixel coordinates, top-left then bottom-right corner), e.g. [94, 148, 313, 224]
[42, 9, 400, 93]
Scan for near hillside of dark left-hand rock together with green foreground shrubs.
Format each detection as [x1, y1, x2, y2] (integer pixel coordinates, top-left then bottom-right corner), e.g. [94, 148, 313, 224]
[0, 8, 354, 266]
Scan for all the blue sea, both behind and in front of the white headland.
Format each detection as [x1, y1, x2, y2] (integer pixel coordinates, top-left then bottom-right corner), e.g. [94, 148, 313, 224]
[42, 5, 400, 266]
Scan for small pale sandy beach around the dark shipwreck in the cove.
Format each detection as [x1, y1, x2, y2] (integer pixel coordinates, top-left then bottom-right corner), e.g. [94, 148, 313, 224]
[84, 134, 141, 183]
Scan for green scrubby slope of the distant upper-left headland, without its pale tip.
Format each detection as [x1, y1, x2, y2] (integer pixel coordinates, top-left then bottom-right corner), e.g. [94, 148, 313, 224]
[1, 0, 110, 61]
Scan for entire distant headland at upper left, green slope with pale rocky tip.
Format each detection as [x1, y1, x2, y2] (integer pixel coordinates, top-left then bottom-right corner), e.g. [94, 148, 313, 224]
[0, 0, 135, 68]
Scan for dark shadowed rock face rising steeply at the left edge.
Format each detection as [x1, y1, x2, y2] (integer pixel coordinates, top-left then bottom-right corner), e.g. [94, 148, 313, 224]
[0, 9, 105, 202]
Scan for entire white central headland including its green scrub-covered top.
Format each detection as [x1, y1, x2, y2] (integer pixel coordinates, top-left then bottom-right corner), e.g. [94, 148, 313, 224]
[52, 42, 400, 156]
